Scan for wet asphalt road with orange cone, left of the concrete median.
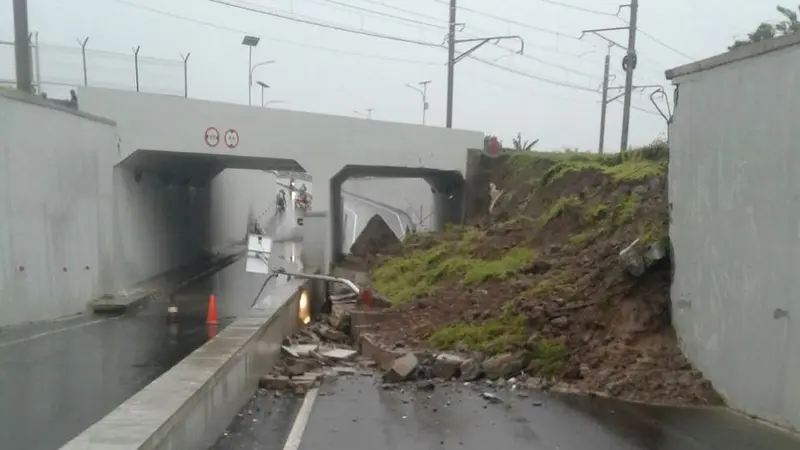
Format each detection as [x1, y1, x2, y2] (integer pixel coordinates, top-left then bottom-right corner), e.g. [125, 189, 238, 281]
[0, 253, 286, 450]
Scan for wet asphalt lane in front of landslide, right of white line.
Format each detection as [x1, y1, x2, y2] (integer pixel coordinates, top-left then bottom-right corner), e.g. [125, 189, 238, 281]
[296, 377, 800, 450]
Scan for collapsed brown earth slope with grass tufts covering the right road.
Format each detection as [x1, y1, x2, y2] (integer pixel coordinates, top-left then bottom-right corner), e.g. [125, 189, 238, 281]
[360, 145, 721, 404]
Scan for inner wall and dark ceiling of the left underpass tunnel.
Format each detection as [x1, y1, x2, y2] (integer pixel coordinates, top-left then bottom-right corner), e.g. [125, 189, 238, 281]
[111, 150, 304, 289]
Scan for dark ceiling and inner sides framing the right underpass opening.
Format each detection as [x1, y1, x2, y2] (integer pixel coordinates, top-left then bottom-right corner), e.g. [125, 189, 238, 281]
[329, 165, 466, 261]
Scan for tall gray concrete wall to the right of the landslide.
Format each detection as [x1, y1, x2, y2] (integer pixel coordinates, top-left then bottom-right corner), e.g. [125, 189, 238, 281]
[669, 37, 800, 429]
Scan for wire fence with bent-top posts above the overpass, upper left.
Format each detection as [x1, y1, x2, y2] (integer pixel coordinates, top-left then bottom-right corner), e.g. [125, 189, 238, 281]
[0, 34, 190, 98]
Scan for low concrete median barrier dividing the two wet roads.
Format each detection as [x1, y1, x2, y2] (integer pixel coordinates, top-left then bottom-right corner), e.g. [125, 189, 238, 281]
[62, 280, 308, 450]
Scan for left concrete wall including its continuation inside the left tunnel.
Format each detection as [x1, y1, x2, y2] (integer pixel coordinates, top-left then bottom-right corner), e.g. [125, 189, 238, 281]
[0, 91, 275, 327]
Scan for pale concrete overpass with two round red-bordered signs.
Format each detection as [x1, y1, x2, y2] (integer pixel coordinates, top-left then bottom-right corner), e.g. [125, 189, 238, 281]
[78, 88, 483, 267]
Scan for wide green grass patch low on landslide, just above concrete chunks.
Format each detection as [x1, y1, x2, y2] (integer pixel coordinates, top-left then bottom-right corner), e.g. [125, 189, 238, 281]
[428, 314, 528, 354]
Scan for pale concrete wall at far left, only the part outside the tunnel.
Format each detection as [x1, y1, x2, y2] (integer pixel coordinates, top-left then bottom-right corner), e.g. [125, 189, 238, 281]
[0, 94, 118, 326]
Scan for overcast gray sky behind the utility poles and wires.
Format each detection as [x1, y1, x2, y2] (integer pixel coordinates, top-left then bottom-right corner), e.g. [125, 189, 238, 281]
[0, 0, 778, 151]
